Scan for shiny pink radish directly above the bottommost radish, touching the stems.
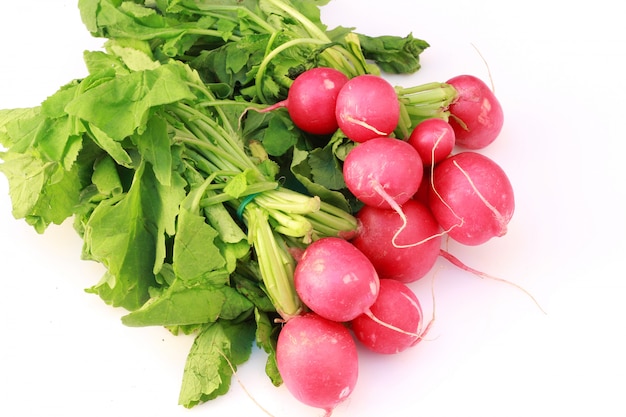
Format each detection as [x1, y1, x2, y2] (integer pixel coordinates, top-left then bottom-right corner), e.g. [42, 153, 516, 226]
[294, 237, 379, 322]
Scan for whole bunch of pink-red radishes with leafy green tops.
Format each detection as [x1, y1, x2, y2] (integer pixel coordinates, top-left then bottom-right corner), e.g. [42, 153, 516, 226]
[0, 0, 515, 416]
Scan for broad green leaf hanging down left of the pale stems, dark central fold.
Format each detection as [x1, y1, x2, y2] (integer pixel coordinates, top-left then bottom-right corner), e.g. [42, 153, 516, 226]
[84, 163, 185, 311]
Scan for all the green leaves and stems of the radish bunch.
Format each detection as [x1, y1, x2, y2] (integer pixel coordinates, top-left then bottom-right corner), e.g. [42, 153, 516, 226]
[0, 0, 450, 407]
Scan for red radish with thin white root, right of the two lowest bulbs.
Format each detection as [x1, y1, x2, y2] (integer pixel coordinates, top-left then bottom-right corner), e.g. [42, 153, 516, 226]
[351, 279, 423, 354]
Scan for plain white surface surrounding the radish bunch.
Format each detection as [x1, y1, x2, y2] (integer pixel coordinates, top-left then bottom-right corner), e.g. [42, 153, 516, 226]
[0, 0, 626, 417]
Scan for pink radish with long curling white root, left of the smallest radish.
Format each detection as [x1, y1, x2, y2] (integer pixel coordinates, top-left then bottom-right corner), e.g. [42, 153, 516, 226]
[343, 137, 424, 208]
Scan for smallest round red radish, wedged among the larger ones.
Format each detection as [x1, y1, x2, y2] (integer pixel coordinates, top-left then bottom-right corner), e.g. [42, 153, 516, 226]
[408, 118, 455, 166]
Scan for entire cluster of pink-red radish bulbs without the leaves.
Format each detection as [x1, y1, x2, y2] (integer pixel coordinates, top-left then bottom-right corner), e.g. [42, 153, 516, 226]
[276, 68, 514, 415]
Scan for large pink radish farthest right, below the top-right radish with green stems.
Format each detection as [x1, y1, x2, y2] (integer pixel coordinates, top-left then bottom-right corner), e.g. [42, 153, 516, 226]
[429, 151, 515, 245]
